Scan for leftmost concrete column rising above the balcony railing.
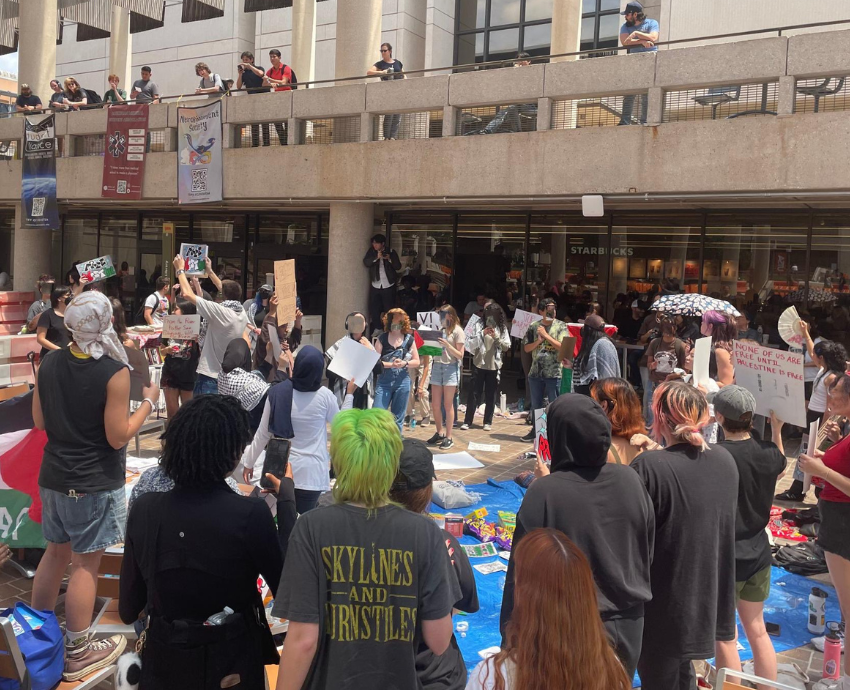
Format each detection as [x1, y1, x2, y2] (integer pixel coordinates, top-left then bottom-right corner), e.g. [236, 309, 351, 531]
[18, 0, 59, 102]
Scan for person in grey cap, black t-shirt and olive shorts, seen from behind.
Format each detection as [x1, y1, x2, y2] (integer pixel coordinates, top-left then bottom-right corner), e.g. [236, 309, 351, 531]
[712, 385, 787, 680]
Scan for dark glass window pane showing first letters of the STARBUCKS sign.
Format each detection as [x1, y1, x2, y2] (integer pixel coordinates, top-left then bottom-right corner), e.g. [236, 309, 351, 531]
[525, 214, 608, 321]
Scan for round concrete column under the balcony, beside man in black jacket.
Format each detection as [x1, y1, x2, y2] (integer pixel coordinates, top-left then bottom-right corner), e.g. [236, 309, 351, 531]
[325, 203, 375, 343]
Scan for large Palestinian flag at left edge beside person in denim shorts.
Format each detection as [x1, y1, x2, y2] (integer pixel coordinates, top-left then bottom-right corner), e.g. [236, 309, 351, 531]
[0, 391, 47, 549]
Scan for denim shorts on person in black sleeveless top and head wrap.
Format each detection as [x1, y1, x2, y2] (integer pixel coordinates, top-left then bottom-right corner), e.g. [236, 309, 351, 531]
[38, 486, 127, 553]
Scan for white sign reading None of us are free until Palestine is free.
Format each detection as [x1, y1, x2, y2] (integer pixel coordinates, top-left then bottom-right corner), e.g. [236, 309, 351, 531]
[728, 340, 806, 427]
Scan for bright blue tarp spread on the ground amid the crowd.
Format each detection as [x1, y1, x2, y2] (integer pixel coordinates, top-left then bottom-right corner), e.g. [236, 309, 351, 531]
[431, 479, 841, 685]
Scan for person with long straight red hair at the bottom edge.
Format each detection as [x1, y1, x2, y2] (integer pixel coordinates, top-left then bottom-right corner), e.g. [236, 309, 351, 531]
[466, 528, 632, 690]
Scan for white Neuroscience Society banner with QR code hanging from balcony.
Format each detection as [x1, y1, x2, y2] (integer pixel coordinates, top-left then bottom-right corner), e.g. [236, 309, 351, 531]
[177, 100, 222, 204]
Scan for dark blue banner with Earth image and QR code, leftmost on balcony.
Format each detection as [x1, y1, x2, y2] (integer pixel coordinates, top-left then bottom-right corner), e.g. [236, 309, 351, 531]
[21, 115, 59, 230]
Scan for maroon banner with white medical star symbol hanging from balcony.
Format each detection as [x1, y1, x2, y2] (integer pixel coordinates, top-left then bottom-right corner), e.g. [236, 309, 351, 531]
[100, 103, 149, 199]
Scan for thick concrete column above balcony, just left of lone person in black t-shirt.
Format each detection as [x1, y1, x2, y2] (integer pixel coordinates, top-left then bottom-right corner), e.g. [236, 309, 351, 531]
[334, 0, 383, 78]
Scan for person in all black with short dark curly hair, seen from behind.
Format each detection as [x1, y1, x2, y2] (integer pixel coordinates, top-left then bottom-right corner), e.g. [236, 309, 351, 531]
[118, 395, 282, 690]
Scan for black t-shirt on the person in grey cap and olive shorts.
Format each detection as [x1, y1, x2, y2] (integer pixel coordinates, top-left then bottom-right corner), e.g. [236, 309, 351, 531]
[719, 438, 788, 582]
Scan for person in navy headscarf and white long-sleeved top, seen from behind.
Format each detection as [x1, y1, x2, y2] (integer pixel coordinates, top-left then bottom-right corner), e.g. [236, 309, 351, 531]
[242, 345, 357, 515]
